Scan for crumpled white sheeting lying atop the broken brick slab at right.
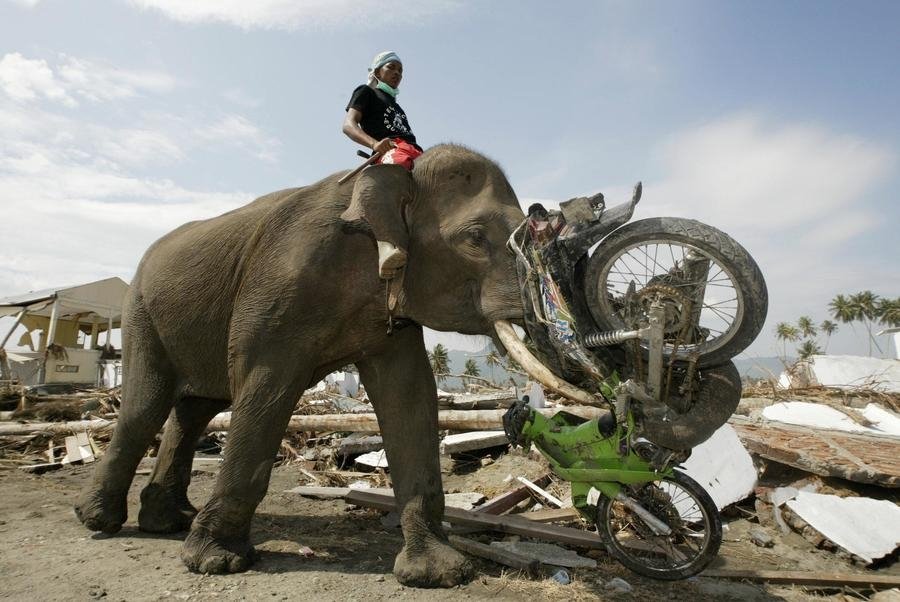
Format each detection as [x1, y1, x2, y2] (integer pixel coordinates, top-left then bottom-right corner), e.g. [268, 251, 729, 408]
[762, 401, 900, 437]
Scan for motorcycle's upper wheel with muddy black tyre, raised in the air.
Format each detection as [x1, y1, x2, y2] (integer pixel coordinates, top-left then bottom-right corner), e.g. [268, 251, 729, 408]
[584, 217, 768, 366]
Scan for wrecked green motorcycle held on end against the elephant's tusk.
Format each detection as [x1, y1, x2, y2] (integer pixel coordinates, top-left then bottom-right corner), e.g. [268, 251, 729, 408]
[497, 184, 768, 579]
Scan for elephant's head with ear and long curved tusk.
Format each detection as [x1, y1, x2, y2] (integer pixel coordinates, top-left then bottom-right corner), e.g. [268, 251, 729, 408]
[344, 144, 594, 403]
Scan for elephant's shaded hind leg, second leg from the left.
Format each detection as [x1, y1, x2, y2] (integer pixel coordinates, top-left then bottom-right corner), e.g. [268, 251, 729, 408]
[138, 397, 230, 533]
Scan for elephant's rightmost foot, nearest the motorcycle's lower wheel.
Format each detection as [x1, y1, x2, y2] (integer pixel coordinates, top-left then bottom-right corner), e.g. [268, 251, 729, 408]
[394, 539, 475, 587]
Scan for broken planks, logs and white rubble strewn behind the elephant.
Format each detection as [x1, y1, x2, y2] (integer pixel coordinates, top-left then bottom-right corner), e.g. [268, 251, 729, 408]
[0, 370, 900, 592]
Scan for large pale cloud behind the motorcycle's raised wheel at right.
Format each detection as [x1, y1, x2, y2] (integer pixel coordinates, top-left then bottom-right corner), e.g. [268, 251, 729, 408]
[637, 114, 900, 355]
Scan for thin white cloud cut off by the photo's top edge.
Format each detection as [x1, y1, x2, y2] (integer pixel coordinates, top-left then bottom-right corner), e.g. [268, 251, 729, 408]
[128, 0, 461, 31]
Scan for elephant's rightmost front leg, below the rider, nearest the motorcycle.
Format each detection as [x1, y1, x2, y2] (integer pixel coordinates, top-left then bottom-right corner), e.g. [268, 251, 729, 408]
[358, 327, 474, 587]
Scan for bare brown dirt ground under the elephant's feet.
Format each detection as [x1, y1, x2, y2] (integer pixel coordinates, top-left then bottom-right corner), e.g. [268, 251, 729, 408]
[0, 457, 897, 601]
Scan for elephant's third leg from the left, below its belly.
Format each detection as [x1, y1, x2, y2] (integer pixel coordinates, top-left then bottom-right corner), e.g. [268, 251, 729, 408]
[181, 358, 308, 573]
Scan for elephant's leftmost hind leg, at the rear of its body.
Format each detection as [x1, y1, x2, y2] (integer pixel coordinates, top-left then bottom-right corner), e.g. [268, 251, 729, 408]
[75, 292, 175, 533]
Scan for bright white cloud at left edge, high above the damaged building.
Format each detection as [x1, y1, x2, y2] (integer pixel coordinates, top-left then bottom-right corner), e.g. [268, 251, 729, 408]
[0, 52, 175, 107]
